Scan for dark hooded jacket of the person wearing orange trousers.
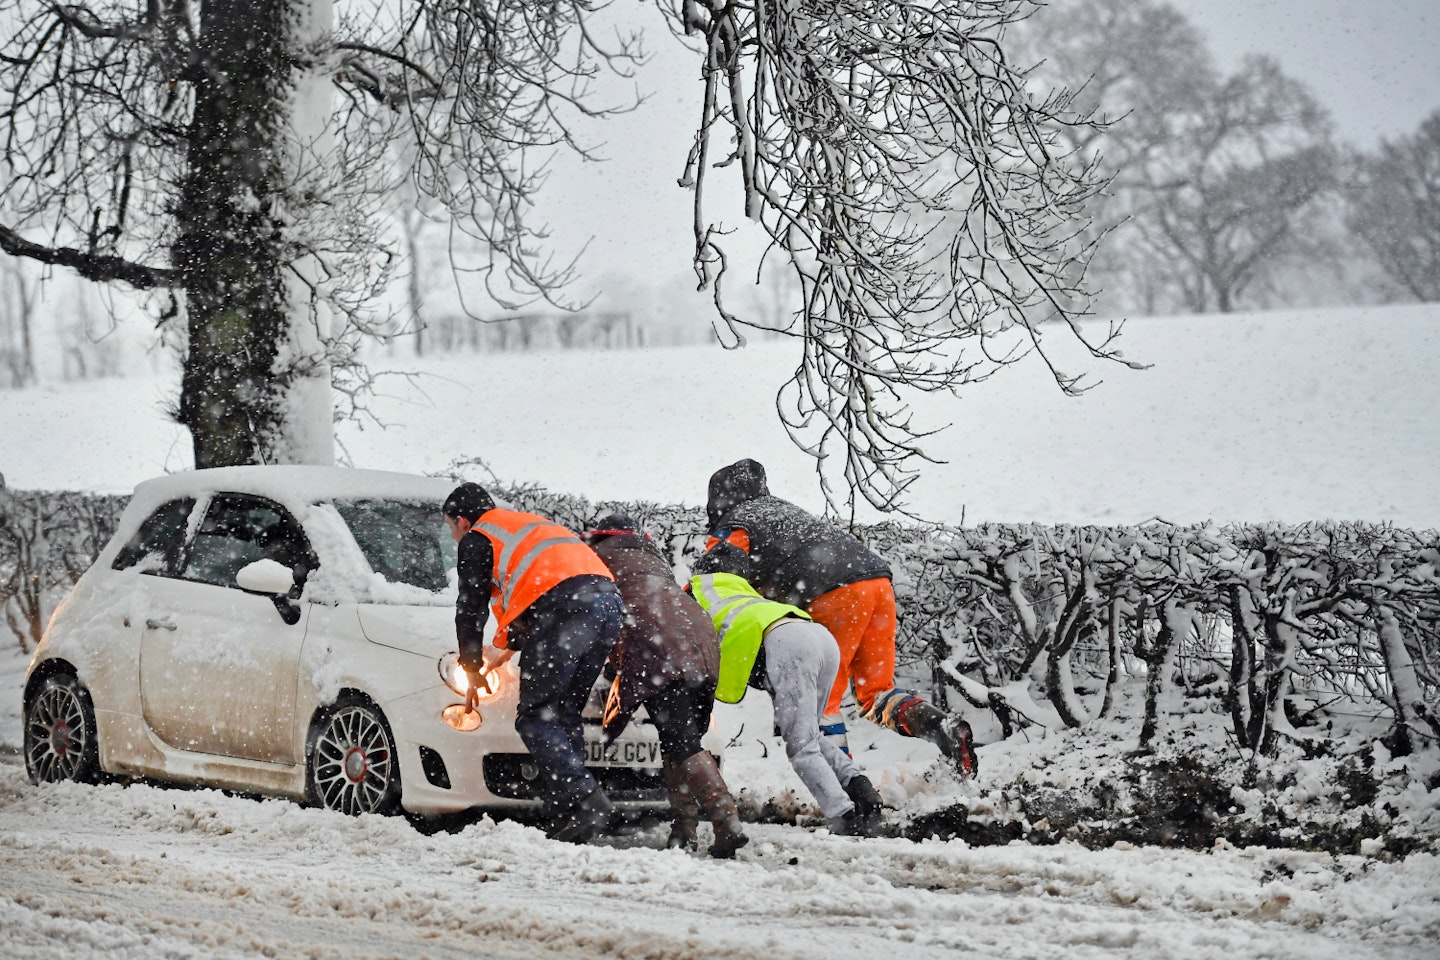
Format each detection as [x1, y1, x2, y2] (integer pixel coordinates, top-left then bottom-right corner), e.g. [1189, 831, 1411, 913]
[694, 461, 891, 607]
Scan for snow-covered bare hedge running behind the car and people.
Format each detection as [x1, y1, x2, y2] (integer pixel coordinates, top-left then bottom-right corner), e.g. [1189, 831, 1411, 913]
[0, 488, 1440, 753]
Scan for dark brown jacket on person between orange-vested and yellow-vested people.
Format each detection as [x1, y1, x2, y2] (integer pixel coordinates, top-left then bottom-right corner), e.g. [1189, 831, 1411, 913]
[586, 524, 720, 740]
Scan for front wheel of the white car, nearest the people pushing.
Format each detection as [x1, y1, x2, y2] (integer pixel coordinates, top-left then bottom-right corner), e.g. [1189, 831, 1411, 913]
[305, 697, 400, 816]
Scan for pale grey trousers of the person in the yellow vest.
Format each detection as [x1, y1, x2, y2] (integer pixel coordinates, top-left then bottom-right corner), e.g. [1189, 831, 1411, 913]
[765, 620, 860, 818]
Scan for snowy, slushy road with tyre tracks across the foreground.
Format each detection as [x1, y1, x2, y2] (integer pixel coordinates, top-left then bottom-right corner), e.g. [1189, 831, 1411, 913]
[0, 754, 1440, 960]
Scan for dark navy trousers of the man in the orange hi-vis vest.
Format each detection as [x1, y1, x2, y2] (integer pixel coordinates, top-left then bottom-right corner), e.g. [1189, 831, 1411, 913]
[516, 580, 625, 809]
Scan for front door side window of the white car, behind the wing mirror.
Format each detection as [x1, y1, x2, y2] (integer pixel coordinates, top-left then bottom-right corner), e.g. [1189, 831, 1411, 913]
[180, 494, 317, 599]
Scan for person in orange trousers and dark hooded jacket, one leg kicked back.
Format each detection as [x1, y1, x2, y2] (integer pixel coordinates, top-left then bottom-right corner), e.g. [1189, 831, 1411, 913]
[694, 459, 978, 777]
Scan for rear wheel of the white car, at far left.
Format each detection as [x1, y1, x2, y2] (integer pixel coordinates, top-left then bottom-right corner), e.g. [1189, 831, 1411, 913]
[23, 674, 99, 783]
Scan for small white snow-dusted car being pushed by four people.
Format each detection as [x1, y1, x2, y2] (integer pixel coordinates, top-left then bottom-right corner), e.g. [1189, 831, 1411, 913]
[23, 466, 721, 816]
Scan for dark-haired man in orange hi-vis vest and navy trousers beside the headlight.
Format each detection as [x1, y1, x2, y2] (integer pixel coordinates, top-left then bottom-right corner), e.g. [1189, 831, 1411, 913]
[442, 484, 625, 843]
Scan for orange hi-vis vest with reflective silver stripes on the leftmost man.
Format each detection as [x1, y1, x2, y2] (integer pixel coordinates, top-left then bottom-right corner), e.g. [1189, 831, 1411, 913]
[471, 507, 615, 649]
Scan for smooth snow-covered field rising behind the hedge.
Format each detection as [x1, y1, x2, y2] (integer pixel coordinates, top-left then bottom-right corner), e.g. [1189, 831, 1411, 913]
[0, 305, 1440, 528]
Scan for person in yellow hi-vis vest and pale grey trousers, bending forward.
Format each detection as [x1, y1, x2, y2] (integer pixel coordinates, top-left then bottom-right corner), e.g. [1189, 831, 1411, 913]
[690, 573, 883, 836]
